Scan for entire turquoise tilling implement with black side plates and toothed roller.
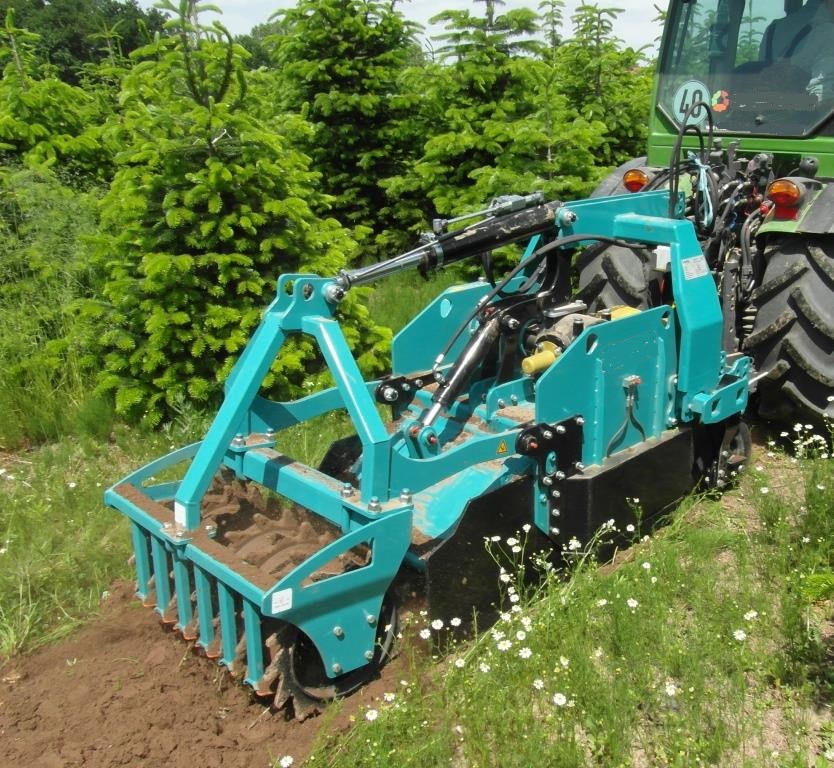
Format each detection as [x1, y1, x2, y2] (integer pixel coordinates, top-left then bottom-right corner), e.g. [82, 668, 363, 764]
[105, 192, 750, 718]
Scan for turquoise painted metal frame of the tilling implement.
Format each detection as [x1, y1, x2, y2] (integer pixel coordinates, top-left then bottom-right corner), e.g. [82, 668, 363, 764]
[105, 191, 749, 690]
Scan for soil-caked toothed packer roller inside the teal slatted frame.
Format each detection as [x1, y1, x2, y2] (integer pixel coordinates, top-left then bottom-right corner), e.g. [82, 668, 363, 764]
[130, 470, 374, 721]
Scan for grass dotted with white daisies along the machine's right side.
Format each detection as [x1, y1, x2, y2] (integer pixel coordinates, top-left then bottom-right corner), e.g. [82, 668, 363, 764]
[305, 436, 834, 768]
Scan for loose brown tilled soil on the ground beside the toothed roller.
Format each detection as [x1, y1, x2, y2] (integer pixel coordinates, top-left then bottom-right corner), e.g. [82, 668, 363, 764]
[0, 583, 393, 768]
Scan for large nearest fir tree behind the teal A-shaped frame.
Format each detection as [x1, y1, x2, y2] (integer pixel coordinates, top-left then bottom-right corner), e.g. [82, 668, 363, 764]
[82, 0, 386, 424]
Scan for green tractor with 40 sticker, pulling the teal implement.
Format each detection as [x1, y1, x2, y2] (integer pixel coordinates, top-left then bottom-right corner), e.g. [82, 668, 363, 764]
[578, 0, 834, 426]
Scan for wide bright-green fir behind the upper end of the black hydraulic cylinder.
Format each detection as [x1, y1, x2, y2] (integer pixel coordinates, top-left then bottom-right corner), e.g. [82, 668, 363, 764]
[388, 3, 606, 220]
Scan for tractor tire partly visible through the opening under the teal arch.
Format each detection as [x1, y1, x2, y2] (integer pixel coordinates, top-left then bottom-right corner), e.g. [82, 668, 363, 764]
[576, 245, 651, 312]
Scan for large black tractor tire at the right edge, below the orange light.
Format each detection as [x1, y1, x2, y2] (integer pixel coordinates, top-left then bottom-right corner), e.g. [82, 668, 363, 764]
[744, 236, 834, 426]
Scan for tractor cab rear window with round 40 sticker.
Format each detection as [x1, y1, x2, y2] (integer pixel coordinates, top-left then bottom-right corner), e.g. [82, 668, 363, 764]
[658, 0, 834, 137]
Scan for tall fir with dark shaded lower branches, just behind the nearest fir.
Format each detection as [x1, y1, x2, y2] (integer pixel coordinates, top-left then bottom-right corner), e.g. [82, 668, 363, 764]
[272, 0, 421, 257]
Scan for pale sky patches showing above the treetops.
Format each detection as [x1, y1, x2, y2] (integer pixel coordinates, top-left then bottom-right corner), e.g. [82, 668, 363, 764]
[139, 0, 662, 48]
